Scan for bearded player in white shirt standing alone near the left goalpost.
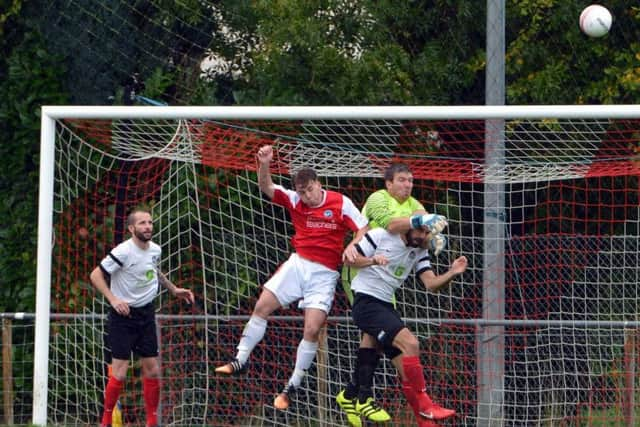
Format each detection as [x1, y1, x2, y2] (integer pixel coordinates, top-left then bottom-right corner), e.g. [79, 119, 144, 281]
[90, 209, 194, 427]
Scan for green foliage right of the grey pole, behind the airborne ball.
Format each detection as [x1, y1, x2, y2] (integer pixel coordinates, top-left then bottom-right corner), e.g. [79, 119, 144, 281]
[506, 0, 640, 104]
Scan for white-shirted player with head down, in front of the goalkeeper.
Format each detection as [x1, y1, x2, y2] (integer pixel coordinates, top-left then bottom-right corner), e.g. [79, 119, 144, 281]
[338, 226, 467, 427]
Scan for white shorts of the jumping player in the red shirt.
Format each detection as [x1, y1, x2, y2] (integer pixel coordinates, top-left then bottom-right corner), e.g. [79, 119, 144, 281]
[264, 253, 338, 314]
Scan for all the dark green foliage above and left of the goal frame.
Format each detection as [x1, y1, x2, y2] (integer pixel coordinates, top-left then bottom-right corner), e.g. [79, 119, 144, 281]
[0, 0, 640, 316]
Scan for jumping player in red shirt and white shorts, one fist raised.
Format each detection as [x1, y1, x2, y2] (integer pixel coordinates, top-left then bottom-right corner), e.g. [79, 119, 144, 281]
[216, 145, 367, 410]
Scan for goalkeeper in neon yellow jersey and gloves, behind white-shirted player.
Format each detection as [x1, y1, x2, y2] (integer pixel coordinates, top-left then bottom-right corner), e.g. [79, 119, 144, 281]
[336, 163, 447, 427]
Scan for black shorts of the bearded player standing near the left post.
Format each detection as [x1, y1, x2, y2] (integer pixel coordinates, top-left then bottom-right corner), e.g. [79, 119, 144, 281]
[107, 303, 159, 360]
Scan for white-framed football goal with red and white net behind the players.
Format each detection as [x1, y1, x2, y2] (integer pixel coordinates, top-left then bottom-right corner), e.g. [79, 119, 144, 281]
[34, 106, 640, 426]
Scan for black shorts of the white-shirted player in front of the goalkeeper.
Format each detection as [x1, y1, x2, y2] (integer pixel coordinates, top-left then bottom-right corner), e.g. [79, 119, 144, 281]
[351, 293, 405, 347]
